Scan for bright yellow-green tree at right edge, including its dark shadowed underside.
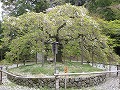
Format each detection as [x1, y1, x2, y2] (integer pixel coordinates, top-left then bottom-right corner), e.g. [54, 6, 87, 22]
[100, 20, 120, 55]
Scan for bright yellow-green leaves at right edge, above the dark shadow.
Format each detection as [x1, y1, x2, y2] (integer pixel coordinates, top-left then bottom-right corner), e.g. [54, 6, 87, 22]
[100, 20, 120, 47]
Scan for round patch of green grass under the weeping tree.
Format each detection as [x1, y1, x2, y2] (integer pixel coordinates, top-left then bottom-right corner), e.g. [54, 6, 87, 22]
[9, 62, 101, 76]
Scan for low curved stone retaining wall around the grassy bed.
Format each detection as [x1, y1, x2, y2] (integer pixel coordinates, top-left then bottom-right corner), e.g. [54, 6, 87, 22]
[7, 73, 106, 88]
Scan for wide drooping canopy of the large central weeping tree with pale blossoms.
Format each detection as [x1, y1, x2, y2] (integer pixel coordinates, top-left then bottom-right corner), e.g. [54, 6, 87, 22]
[2, 4, 117, 62]
